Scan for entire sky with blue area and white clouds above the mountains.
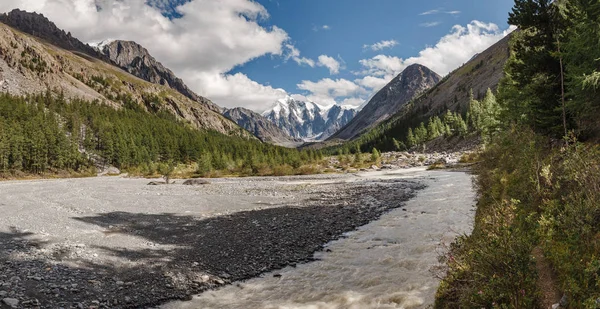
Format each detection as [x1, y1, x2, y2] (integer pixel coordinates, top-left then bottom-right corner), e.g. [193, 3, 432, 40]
[0, 0, 513, 112]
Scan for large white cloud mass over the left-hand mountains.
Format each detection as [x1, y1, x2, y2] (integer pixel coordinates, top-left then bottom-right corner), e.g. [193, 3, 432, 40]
[0, 0, 290, 107]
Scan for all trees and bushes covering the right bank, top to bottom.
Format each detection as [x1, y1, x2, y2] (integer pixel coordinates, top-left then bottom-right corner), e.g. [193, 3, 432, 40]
[435, 0, 600, 308]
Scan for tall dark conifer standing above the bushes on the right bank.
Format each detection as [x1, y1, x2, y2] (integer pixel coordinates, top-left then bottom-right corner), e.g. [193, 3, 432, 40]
[500, 0, 564, 136]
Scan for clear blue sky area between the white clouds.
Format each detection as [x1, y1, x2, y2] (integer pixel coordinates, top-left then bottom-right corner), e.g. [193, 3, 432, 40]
[232, 0, 514, 100]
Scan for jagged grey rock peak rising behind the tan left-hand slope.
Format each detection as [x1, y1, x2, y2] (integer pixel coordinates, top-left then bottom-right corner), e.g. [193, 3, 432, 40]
[100, 40, 222, 113]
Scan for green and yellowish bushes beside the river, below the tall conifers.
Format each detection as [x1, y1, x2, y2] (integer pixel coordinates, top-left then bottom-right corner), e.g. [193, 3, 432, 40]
[435, 127, 600, 308]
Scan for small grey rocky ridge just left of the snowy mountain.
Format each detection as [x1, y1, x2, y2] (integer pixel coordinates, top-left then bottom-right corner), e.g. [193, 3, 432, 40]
[223, 107, 302, 147]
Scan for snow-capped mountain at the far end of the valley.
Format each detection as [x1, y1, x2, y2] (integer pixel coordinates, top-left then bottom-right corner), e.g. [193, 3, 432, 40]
[262, 96, 357, 140]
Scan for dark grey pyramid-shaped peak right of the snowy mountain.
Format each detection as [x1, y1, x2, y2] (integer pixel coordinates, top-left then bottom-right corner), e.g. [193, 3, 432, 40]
[329, 64, 441, 140]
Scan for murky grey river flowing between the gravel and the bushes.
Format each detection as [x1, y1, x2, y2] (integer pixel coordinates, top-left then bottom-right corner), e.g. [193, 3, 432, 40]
[163, 170, 475, 309]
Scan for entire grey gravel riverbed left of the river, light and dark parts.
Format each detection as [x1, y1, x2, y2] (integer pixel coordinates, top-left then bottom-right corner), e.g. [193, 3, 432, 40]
[0, 170, 424, 308]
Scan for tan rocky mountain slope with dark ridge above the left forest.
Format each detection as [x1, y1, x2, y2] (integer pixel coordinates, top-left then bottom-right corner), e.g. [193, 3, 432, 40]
[0, 11, 250, 137]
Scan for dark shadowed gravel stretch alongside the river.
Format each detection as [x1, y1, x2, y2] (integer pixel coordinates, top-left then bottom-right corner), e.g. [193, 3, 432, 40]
[0, 182, 422, 308]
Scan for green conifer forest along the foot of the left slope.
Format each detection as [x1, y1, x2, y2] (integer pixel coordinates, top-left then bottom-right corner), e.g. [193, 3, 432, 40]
[0, 93, 322, 175]
